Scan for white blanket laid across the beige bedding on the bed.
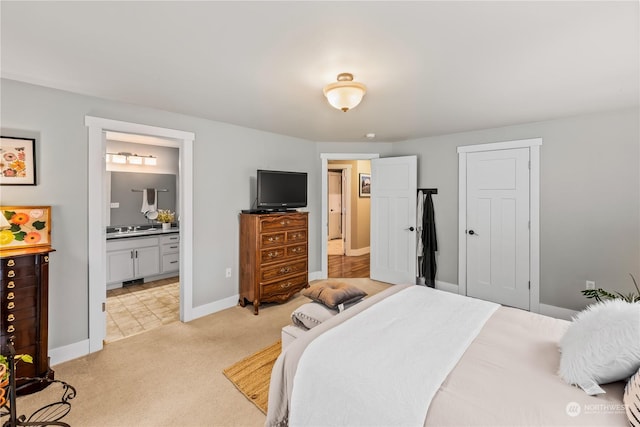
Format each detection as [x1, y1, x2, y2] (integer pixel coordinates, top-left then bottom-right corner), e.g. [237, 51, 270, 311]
[289, 286, 498, 426]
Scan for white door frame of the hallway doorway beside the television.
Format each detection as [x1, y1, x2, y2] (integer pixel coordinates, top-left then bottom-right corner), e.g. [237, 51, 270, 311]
[318, 153, 380, 279]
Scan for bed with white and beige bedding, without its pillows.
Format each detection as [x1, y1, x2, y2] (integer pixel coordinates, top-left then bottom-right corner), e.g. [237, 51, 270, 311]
[266, 286, 629, 426]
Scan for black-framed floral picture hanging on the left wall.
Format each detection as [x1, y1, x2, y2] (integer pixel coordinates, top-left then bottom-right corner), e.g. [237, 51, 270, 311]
[0, 136, 36, 185]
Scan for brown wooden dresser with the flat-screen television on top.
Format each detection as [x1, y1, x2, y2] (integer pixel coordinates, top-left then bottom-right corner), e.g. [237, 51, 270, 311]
[240, 212, 309, 314]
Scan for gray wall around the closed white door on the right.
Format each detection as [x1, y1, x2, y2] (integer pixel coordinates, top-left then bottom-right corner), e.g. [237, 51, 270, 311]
[393, 109, 640, 310]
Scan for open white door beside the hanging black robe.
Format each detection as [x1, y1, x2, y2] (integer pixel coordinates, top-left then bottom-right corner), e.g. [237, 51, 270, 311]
[370, 156, 418, 284]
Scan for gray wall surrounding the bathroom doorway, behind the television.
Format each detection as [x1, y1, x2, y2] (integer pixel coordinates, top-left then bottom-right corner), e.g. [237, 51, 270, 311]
[0, 79, 320, 348]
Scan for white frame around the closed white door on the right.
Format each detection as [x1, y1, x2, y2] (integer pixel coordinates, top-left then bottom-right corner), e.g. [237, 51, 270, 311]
[458, 138, 542, 313]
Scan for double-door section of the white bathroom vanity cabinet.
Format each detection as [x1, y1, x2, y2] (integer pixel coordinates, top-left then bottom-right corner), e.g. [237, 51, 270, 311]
[107, 237, 161, 285]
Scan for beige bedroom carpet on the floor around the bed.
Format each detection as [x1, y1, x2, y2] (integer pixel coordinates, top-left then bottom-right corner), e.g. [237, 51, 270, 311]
[16, 279, 389, 427]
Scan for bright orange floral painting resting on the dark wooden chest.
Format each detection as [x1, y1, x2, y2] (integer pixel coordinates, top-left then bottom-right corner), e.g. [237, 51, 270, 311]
[0, 206, 51, 250]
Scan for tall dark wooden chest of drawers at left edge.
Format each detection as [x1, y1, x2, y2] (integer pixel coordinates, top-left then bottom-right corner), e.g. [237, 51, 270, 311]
[0, 246, 54, 394]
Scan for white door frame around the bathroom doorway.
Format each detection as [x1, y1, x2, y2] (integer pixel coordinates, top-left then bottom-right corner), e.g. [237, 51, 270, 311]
[85, 116, 195, 353]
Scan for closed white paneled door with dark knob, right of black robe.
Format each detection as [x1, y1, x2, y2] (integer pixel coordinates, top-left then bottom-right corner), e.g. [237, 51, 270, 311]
[466, 148, 530, 310]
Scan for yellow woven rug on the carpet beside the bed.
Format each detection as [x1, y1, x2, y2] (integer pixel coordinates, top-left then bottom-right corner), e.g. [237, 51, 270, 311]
[222, 340, 282, 414]
